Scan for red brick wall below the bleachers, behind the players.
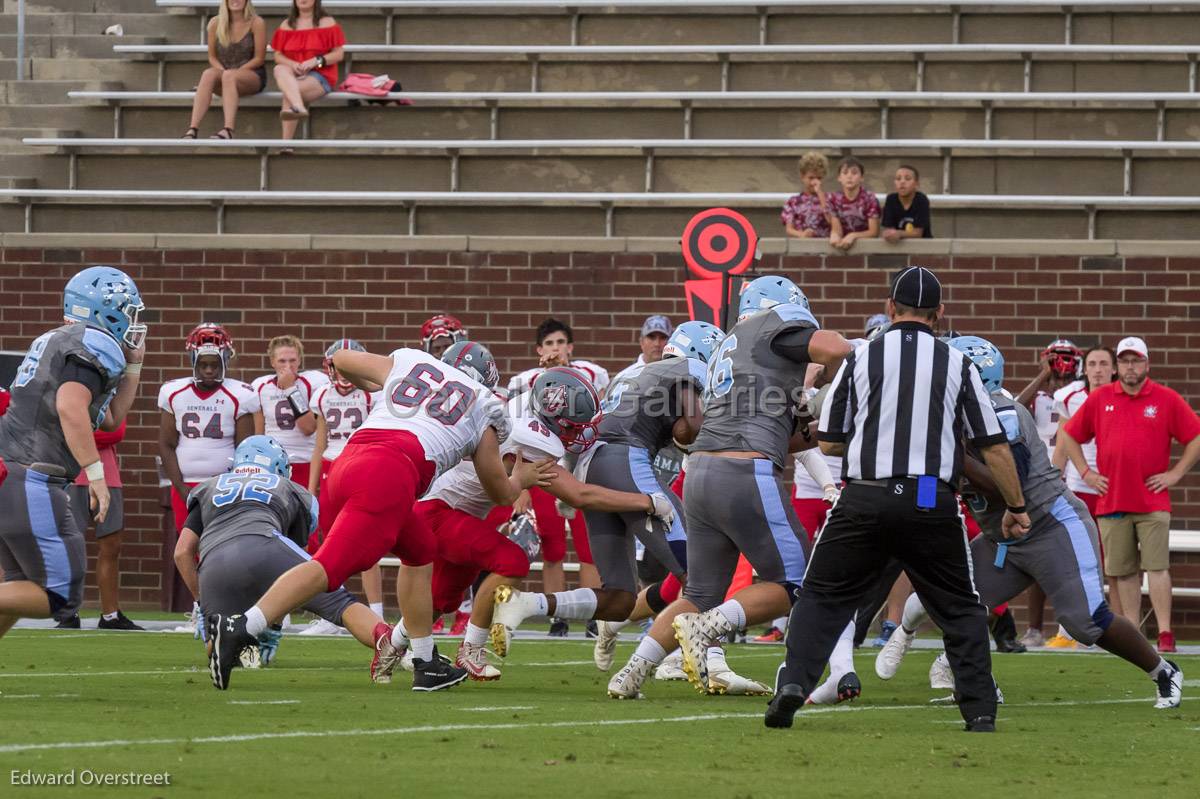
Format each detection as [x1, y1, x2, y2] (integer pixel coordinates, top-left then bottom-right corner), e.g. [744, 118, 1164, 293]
[0, 242, 1200, 635]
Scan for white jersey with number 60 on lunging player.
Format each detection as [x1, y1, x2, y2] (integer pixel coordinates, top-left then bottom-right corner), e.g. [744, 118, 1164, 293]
[359, 348, 511, 477]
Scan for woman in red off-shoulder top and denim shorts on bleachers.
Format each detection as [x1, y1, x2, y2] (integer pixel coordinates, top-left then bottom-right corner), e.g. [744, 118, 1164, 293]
[271, 0, 346, 139]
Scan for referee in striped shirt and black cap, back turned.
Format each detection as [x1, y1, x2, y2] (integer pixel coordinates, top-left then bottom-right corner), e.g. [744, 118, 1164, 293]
[764, 266, 1030, 732]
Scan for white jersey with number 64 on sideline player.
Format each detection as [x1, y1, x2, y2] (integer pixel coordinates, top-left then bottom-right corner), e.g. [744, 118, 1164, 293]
[158, 377, 258, 482]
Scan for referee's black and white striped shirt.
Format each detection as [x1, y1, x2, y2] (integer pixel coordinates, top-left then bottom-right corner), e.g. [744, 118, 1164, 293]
[817, 322, 1008, 486]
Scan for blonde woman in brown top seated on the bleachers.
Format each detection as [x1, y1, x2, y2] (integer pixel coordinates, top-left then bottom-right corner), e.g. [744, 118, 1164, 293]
[184, 0, 266, 139]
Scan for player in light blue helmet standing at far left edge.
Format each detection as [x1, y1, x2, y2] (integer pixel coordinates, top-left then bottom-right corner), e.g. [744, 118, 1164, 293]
[0, 266, 146, 636]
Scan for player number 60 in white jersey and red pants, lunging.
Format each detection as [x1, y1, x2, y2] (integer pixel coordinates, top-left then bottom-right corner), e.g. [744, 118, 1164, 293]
[210, 338, 554, 691]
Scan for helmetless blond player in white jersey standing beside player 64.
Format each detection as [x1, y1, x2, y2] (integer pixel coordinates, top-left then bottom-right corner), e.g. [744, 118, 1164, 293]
[251, 336, 329, 488]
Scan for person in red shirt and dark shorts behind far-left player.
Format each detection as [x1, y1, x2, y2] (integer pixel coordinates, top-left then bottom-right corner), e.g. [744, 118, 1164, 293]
[59, 422, 142, 630]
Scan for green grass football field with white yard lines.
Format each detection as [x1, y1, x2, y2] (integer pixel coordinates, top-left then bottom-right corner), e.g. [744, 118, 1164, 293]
[0, 630, 1200, 799]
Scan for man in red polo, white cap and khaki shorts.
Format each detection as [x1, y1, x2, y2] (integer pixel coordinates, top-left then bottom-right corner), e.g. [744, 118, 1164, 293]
[1062, 336, 1200, 651]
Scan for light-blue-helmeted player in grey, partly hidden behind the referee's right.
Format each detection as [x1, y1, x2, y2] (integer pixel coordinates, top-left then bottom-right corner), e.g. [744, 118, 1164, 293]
[876, 336, 1183, 709]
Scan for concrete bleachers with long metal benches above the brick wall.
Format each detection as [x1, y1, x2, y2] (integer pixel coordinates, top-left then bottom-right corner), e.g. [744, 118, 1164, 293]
[0, 0, 1200, 239]
